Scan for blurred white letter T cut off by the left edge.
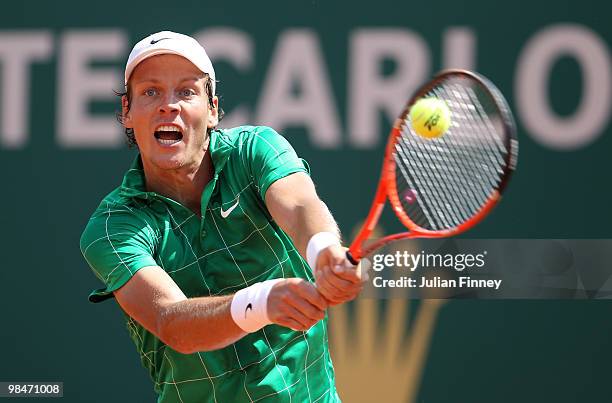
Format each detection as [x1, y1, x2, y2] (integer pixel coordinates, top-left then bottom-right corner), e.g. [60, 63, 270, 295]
[0, 31, 53, 149]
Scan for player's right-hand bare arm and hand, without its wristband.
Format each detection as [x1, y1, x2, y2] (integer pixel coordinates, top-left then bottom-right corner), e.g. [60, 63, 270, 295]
[265, 172, 363, 305]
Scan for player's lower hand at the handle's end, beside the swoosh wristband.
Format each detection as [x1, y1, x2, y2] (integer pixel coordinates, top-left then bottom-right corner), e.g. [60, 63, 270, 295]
[268, 278, 328, 331]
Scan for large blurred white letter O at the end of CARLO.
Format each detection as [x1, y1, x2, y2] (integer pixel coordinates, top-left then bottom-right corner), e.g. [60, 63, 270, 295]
[515, 24, 612, 150]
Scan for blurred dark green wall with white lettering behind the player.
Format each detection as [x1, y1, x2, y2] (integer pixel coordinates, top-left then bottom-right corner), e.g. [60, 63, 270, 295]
[0, 0, 612, 403]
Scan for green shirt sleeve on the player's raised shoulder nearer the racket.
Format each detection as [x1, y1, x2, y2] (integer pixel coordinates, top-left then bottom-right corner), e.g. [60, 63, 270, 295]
[245, 126, 310, 200]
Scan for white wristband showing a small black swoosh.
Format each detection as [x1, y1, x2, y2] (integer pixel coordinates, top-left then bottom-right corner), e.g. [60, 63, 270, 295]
[230, 278, 283, 333]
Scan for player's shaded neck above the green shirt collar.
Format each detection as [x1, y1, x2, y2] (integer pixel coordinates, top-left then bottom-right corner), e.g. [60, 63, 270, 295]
[143, 147, 214, 216]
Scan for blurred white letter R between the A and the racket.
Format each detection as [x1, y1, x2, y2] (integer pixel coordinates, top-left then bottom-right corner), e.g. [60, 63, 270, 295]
[347, 28, 430, 148]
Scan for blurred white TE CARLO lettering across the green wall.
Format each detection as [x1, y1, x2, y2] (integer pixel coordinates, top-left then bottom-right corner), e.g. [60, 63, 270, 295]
[0, 24, 612, 150]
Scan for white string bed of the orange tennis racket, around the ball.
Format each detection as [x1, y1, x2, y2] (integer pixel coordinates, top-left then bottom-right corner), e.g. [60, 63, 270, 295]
[394, 78, 508, 230]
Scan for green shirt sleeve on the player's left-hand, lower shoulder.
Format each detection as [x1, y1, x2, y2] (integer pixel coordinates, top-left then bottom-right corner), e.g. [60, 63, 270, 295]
[80, 208, 158, 302]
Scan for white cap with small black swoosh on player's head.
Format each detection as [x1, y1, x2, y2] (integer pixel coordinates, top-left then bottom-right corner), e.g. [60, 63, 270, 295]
[125, 31, 216, 95]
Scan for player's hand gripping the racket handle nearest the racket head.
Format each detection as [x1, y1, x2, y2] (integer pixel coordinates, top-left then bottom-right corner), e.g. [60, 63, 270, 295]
[315, 245, 365, 306]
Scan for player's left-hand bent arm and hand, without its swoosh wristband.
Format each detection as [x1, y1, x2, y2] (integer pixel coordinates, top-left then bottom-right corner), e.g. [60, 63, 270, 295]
[114, 266, 327, 354]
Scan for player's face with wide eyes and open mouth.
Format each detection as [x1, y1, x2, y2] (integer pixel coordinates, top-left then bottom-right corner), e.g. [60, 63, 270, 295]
[123, 54, 218, 170]
